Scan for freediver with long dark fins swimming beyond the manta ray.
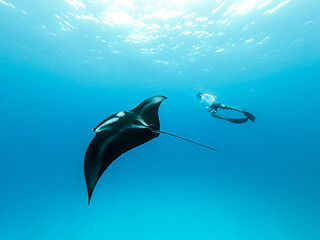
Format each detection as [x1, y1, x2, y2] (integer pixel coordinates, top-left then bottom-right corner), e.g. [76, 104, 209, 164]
[197, 92, 256, 123]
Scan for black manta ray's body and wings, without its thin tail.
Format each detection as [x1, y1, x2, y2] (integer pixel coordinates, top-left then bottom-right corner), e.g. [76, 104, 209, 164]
[84, 96, 166, 203]
